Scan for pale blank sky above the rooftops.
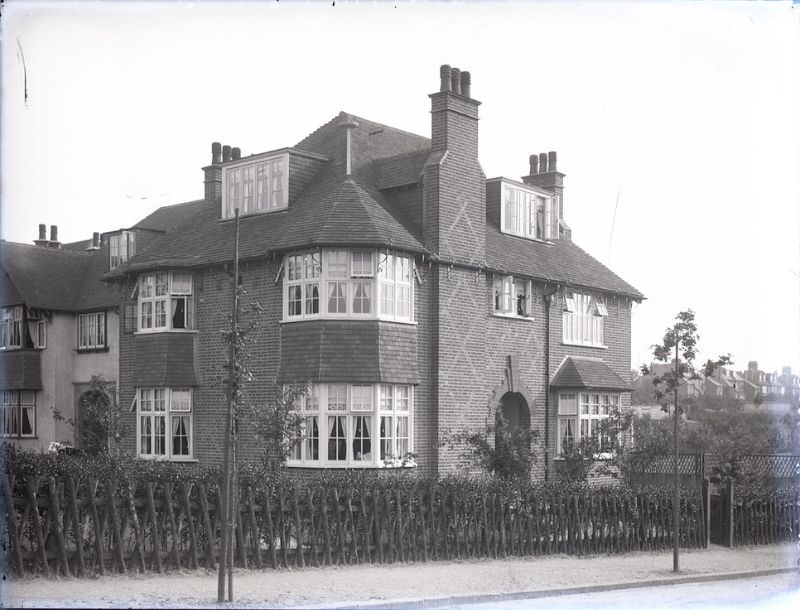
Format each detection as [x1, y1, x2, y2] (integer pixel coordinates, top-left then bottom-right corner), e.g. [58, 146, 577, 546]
[0, 0, 800, 372]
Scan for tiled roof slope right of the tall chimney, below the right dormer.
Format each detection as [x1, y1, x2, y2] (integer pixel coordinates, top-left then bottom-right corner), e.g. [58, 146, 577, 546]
[486, 220, 643, 299]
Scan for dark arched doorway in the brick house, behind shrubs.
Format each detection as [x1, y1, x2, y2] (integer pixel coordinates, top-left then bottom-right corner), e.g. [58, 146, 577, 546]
[494, 392, 532, 478]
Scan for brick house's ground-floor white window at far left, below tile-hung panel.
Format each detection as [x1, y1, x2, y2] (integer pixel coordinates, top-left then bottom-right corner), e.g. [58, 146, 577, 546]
[135, 388, 193, 460]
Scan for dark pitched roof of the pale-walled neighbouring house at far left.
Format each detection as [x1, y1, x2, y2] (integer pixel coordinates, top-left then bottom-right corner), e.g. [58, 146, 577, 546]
[0, 241, 119, 311]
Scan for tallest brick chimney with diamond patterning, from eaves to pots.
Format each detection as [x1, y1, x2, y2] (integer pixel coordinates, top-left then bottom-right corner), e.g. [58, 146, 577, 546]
[423, 65, 486, 264]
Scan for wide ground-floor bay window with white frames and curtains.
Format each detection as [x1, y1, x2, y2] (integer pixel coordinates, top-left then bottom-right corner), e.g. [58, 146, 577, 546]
[288, 383, 413, 467]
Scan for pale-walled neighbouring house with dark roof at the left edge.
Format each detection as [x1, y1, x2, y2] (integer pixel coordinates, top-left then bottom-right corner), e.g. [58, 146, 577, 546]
[0, 225, 119, 450]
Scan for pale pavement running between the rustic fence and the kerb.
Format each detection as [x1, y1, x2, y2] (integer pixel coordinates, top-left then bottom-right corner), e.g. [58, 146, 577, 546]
[6, 544, 800, 608]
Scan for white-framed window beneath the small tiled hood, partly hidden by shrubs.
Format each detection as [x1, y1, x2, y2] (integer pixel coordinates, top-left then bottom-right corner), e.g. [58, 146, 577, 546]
[556, 390, 622, 456]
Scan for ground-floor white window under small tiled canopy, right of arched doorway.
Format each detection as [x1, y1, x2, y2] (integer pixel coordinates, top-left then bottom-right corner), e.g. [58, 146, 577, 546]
[557, 392, 620, 455]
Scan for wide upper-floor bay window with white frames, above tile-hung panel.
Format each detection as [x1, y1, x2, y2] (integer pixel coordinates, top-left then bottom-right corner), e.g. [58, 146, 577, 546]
[284, 249, 413, 322]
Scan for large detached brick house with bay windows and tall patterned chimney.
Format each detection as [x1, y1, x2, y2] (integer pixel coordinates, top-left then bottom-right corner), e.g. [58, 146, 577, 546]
[108, 66, 643, 476]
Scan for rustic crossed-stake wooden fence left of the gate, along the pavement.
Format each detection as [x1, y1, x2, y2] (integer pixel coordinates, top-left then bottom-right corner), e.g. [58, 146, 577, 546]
[2, 475, 706, 576]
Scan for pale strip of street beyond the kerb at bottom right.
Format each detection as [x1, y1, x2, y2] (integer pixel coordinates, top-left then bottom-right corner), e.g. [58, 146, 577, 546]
[450, 574, 800, 610]
